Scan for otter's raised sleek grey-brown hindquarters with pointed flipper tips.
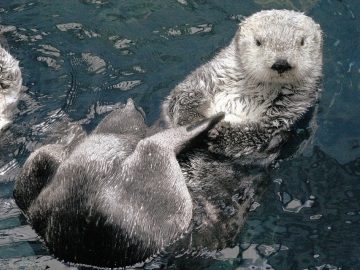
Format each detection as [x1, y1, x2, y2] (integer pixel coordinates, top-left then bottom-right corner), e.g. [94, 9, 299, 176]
[14, 100, 224, 267]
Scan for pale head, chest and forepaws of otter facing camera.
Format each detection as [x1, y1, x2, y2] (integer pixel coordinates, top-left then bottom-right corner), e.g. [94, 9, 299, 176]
[162, 10, 322, 164]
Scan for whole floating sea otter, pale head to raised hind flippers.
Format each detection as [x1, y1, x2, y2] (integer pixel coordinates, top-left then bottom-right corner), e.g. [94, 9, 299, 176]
[14, 10, 322, 267]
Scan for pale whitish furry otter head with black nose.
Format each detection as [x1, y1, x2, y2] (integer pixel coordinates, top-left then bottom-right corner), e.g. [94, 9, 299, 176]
[235, 10, 322, 84]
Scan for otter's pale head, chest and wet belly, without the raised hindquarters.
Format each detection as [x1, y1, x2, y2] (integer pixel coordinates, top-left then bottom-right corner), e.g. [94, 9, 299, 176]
[153, 11, 322, 258]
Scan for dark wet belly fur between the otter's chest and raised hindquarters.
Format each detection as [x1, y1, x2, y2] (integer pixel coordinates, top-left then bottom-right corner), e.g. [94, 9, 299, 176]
[167, 150, 269, 256]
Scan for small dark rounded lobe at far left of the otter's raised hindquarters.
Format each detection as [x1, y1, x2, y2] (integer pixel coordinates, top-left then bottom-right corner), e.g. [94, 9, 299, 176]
[13, 144, 65, 212]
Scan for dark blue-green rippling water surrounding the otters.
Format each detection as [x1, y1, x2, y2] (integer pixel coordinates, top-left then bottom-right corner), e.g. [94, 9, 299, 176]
[0, 0, 360, 269]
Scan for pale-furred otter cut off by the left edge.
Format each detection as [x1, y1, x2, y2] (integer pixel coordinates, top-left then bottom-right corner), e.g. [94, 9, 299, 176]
[0, 28, 22, 130]
